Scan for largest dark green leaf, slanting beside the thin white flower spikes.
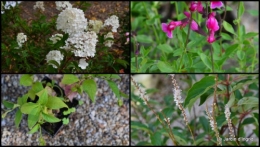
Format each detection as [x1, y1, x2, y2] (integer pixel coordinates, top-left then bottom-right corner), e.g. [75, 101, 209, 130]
[184, 76, 215, 109]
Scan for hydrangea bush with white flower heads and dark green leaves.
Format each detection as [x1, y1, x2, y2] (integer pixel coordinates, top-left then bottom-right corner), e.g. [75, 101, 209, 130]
[1, 1, 129, 73]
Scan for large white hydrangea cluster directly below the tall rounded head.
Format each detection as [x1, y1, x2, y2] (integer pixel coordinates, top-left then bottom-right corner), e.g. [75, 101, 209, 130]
[62, 31, 98, 57]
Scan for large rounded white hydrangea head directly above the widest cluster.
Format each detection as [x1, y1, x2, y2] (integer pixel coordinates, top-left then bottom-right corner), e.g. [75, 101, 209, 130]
[56, 8, 87, 34]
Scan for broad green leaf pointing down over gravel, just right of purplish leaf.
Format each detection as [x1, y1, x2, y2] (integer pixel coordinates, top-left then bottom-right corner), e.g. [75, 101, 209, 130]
[82, 79, 97, 103]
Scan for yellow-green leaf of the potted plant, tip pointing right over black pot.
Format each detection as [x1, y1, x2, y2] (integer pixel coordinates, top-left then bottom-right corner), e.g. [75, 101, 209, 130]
[46, 96, 68, 109]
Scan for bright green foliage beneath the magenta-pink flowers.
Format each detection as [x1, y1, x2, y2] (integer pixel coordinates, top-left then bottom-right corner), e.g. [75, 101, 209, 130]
[131, 1, 259, 73]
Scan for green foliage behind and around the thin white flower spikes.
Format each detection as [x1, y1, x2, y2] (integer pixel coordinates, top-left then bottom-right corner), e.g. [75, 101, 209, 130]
[131, 74, 259, 146]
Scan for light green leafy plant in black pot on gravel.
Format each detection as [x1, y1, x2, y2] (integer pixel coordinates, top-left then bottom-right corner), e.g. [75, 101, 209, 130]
[2, 74, 128, 145]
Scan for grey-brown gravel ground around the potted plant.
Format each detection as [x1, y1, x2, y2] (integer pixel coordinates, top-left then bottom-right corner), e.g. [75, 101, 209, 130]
[1, 74, 129, 145]
